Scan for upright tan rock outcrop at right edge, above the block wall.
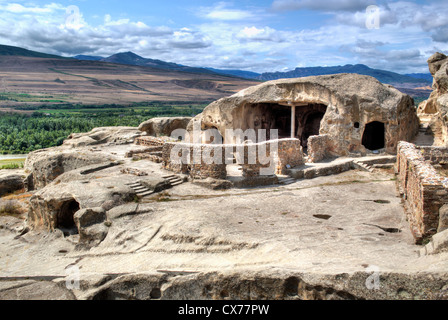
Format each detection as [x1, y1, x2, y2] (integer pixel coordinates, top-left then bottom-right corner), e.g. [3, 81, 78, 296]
[418, 52, 448, 146]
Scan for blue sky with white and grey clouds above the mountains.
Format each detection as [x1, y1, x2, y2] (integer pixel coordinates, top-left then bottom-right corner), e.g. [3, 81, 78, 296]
[0, 0, 448, 73]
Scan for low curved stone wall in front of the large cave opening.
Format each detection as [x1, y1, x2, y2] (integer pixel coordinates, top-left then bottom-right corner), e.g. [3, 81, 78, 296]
[162, 139, 304, 179]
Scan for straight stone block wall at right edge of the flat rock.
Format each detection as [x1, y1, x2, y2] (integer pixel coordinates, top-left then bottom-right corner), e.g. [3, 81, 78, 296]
[396, 142, 448, 244]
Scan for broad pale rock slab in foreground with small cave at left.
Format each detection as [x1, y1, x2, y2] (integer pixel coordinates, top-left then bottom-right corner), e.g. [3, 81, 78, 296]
[0, 140, 448, 299]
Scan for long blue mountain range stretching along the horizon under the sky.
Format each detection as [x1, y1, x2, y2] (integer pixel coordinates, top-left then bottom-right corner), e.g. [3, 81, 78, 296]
[0, 45, 432, 103]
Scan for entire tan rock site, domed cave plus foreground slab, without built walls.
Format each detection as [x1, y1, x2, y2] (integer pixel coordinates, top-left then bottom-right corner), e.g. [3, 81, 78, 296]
[0, 80, 448, 300]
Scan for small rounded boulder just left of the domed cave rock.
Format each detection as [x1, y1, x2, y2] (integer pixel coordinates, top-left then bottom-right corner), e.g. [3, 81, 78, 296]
[138, 117, 191, 137]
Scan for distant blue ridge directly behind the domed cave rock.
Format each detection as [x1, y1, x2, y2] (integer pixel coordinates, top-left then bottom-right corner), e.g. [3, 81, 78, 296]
[258, 64, 428, 86]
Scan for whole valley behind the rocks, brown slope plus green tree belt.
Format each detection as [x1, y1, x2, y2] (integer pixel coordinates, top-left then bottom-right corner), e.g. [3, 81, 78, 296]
[0, 53, 259, 158]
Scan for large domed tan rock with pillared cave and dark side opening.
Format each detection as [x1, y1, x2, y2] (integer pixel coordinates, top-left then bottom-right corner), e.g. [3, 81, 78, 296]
[188, 74, 419, 156]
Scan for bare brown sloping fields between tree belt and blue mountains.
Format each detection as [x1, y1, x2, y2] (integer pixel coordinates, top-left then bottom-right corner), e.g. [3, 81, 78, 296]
[0, 56, 259, 108]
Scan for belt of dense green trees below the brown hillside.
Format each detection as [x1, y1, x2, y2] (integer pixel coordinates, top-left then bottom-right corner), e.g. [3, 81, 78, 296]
[0, 105, 204, 154]
